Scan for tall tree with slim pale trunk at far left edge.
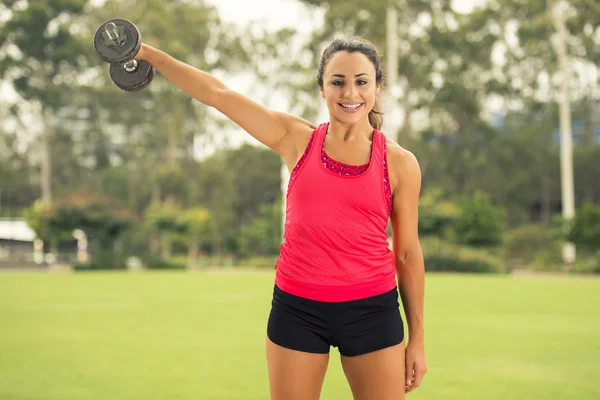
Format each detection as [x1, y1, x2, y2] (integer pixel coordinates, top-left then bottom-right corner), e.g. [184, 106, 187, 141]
[0, 0, 87, 204]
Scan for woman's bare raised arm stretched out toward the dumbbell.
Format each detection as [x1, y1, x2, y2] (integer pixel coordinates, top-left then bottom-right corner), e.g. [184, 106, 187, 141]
[135, 44, 314, 158]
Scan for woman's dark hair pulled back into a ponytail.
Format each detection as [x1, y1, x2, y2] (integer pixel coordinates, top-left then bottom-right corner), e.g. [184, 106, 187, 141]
[317, 38, 384, 130]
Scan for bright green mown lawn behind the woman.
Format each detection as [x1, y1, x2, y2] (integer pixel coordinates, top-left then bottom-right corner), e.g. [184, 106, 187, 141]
[0, 271, 600, 400]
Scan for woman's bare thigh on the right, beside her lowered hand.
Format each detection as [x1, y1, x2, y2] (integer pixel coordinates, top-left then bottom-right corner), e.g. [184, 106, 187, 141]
[341, 342, 405, 400]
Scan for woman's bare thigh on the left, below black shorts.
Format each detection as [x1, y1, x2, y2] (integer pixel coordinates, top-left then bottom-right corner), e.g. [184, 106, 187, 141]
[266, 337, 329, 400]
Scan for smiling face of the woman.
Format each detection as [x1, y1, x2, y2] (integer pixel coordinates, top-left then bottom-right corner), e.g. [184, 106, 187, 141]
[321, 51, 379, 125]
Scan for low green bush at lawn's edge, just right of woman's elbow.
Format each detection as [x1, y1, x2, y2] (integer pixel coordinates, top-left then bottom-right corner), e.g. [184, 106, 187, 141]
[421, 237, 506, 273]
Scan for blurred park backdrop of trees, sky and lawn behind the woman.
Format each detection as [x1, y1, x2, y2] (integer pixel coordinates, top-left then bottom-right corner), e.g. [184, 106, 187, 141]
[0, 0, 600, 399]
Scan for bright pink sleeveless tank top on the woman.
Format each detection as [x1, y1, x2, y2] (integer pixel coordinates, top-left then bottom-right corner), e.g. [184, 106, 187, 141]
[275, 123, 396, 302]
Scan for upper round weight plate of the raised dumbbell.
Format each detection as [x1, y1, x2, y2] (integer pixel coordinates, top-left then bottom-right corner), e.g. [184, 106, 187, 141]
[94, 18, 142, 63]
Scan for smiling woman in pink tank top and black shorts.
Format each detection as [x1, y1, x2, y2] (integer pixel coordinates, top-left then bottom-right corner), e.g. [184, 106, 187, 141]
[136, 39, 426, 400]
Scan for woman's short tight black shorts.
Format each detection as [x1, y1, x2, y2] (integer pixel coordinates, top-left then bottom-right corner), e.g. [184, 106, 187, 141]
[267, 285, 404, 357]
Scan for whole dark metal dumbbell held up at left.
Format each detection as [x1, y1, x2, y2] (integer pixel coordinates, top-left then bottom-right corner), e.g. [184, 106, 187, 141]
[94, 19, 156, 92]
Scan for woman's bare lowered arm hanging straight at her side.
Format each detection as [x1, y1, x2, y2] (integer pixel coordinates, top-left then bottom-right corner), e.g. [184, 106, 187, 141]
[388, 146, 427, 393]
